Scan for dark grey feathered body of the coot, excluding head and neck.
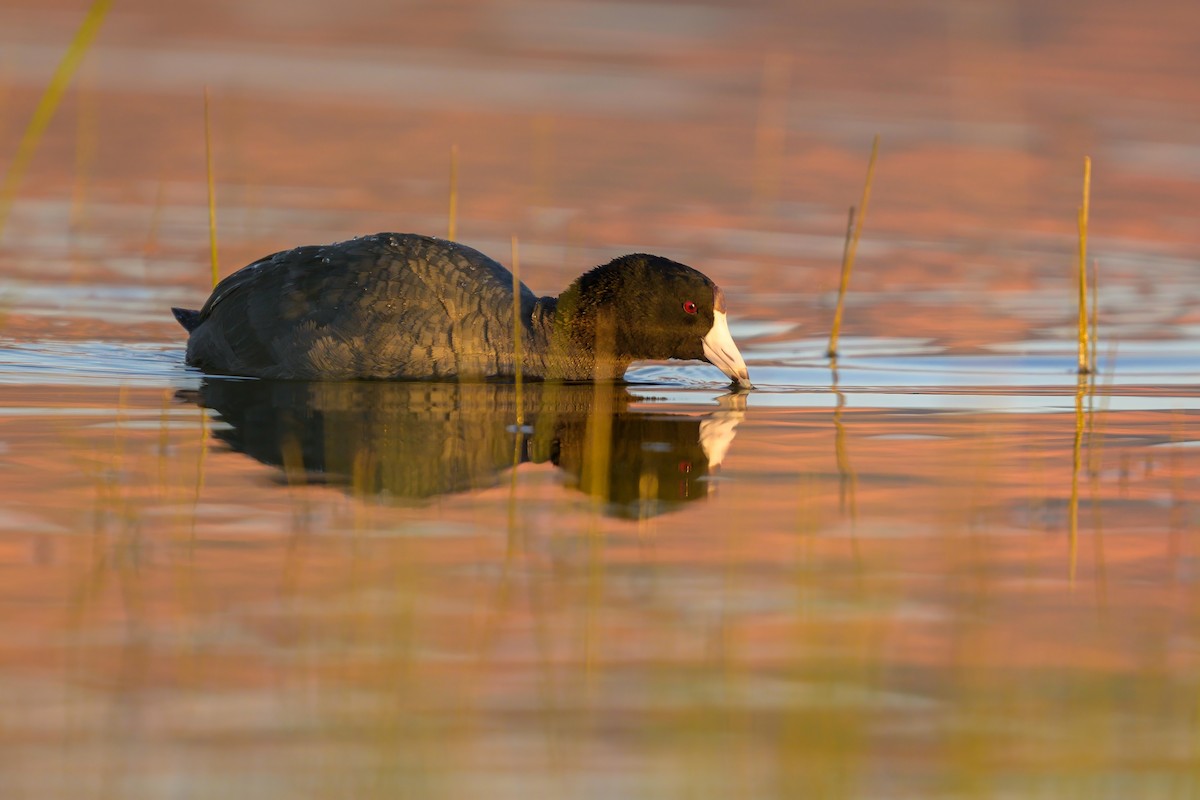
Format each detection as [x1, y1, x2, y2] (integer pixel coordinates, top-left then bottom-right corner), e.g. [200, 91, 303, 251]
[180, 233, 536, 380]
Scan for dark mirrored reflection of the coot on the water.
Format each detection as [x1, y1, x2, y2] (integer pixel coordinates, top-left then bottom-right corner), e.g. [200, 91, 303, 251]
[181, 379, 745, 517]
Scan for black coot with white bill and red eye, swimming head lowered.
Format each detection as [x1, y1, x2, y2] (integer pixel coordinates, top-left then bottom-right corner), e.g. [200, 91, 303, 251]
[173, 233, 751, 387]
